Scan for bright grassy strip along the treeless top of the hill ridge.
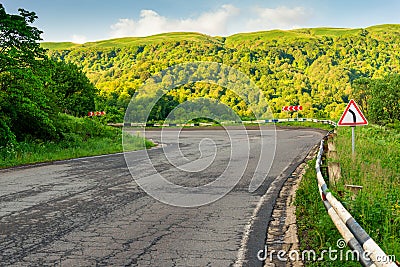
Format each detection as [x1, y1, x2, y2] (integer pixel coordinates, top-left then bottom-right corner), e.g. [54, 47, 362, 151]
[42, 24, 400, 50]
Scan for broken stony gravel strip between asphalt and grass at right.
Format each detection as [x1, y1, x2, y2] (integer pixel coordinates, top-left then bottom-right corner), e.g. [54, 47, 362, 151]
[264, 145, 318, 267]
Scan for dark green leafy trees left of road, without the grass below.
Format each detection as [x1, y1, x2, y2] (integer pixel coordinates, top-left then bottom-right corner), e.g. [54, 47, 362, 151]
[0, 4, 96, 148]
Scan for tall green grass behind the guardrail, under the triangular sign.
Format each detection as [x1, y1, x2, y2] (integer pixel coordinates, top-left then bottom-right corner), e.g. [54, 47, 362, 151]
[335, 126, 400, 259]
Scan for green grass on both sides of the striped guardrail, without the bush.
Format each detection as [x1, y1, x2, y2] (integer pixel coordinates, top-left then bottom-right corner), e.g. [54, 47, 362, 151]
[295, 125, 400, 266]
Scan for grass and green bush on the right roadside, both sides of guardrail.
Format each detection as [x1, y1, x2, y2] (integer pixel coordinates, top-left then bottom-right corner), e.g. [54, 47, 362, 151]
[296, 66, 400, 266]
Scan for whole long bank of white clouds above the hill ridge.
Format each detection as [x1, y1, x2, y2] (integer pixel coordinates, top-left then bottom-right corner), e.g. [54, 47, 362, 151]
[111, 5, 312, 38]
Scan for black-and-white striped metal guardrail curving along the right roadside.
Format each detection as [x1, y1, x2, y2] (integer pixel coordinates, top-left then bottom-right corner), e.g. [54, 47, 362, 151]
[315, 137, 397, 267]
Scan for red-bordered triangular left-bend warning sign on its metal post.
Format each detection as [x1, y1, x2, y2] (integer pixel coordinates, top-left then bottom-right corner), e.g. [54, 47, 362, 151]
[338, 99, 368, 156]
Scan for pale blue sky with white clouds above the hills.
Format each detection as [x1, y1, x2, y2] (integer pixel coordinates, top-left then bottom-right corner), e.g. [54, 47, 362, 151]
[1, 0, 400, 43]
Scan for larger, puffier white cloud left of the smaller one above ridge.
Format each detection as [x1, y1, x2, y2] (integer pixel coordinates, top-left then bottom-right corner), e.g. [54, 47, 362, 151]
[111, 5, 240, 37]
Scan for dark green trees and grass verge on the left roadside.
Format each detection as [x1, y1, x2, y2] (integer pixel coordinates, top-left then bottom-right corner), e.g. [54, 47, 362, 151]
[0, 4, 152, 168]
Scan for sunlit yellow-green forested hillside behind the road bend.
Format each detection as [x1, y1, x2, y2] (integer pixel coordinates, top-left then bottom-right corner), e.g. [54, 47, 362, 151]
[42, 25, 400, 121]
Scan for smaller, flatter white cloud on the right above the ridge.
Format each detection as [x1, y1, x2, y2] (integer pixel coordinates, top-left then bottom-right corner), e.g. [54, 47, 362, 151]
[247, 6, 312, 31]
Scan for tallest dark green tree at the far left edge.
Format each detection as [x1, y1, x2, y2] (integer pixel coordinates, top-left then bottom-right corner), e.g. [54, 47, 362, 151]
[0, 4, 56, 147]
